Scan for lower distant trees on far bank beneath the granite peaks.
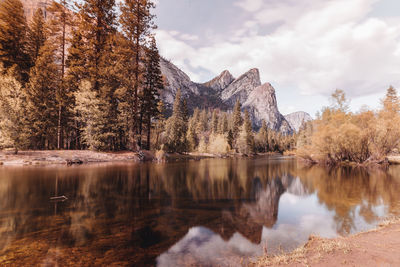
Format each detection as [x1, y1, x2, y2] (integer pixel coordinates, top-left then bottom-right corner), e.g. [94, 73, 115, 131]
[155, 90, 296, 155]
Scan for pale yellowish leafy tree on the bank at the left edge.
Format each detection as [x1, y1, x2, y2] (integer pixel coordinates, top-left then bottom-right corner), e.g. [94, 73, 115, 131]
[0, 67, 30, 154]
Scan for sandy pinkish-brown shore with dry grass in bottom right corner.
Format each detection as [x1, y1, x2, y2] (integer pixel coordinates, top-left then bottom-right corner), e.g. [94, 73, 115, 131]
[251, 219, 400, 267]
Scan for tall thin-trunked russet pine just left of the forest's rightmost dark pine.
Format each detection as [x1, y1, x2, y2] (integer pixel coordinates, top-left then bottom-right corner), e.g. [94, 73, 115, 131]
[120, 0, 155, 151]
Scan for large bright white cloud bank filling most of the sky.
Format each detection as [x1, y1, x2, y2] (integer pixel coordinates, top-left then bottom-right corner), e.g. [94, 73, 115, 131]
[158, 0, 400, 101]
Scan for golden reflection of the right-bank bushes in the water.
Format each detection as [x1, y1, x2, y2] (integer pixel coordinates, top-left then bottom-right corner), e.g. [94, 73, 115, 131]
[298, 166, 400, 234]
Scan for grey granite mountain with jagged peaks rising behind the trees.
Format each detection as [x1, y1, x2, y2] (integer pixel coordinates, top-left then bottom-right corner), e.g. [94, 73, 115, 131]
[161, 59, 294, 134]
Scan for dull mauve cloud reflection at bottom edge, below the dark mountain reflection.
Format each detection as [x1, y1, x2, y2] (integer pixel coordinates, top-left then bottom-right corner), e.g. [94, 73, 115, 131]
[157, 227, 263, 267]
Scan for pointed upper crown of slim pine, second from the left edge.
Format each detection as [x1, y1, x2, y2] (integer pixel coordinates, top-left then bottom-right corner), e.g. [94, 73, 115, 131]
[26, 8, 46, 65]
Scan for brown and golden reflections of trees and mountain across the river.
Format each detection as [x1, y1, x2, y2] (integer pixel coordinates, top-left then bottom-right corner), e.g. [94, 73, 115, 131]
[0, 158, 400, 265]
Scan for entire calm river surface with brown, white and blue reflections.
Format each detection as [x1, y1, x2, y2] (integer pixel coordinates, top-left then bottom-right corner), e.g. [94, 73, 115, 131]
[0, 157, 400, 266]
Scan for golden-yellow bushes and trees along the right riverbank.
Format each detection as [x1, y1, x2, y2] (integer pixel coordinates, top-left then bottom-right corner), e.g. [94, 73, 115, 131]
[297, 87, 400, 164]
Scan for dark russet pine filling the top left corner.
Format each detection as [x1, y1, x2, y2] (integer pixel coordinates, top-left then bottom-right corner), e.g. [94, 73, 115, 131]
[0, 0, 31, 83]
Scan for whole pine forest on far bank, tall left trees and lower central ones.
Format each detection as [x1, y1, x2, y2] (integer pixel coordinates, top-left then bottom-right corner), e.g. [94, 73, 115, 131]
[0, 0, 295, 154]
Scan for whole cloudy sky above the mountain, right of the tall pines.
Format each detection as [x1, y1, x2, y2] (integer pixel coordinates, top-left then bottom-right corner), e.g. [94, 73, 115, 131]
[155, 0, 400, 116]
